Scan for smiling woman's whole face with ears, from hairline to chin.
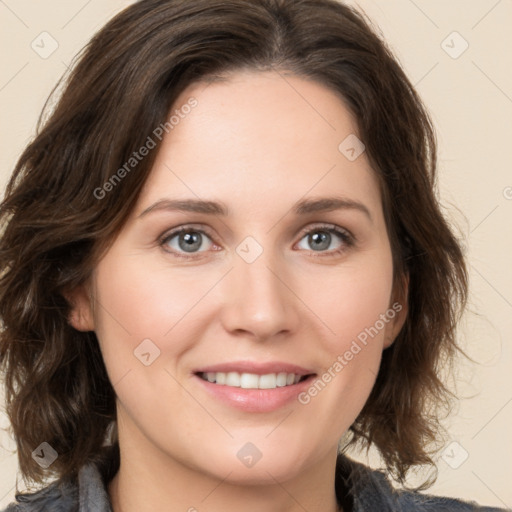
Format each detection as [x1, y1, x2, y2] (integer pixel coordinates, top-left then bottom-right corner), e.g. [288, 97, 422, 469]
[73, 72, 405, 482]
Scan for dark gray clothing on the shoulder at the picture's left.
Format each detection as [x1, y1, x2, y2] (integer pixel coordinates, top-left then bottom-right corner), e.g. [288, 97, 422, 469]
[1, 463, 111, 512]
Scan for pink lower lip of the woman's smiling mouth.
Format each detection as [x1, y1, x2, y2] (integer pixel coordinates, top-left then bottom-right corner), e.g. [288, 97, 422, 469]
[194, 375, 315, 412]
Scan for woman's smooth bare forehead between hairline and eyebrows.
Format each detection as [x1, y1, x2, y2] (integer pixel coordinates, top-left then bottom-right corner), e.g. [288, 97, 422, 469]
[134, 71, 380, 220]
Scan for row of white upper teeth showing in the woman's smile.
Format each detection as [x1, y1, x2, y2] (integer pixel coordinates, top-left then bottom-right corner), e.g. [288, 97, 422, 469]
[200, 372, 302, 389]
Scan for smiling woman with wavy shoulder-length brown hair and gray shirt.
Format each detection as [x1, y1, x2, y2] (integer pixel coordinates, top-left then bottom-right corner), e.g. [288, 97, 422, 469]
[0, 0, 504, 512]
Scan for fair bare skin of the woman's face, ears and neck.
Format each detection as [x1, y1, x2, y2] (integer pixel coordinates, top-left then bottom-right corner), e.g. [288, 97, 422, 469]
[70, 72, 406, 512]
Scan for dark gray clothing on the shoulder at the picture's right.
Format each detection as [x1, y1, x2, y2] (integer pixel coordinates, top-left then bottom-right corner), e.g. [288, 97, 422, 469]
[336, 455, 505, 512]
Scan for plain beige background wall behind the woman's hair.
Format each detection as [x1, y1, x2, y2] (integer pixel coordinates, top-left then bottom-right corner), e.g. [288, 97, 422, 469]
[0, 0, 512, 508]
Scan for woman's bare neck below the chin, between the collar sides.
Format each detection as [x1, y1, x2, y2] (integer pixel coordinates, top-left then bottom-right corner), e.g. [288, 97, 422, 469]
[108, 418, 341, 512]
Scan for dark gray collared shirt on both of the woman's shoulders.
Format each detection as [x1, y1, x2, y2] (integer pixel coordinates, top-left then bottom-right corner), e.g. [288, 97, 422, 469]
[3, 455, 511, 512]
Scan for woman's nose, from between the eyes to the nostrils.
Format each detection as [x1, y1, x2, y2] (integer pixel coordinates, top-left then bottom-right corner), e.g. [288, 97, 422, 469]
[221, 247, 300, 341]
